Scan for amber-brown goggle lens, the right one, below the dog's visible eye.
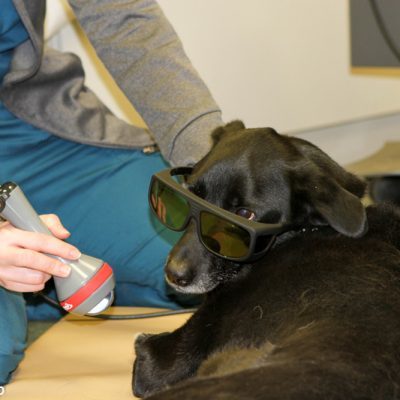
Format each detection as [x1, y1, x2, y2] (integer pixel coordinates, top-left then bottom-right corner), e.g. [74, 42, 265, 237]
[200, 211, 251, 258]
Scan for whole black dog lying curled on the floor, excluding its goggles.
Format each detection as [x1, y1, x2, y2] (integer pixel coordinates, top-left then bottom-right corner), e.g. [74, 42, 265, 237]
[133, 122, 400, 400]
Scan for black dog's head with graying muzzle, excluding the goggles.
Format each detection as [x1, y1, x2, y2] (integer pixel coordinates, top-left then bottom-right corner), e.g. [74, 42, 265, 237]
[165, 121, 367, 293]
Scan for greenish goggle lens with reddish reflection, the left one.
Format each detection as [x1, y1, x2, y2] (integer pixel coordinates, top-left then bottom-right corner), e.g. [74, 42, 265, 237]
[150, 179, 190, 230]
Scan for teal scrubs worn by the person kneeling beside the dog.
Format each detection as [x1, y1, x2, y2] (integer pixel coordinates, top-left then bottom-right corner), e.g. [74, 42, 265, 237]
[0, 0, 182, 385]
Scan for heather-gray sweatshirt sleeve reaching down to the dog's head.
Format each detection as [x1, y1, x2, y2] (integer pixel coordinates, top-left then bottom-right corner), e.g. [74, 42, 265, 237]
[69, 0, 222, 165]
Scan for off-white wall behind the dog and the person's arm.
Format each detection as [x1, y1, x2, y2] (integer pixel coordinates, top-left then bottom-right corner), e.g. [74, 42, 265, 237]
[48, 0, 400, 162]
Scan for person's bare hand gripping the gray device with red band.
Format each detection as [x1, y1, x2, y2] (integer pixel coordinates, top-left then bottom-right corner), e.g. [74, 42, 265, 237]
[0, 214, 81, 292]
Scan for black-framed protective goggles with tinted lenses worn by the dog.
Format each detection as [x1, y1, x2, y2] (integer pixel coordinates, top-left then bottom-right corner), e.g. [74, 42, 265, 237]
[149, 167, 289, 262]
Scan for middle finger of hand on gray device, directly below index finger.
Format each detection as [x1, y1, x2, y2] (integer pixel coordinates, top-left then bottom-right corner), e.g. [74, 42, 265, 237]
[0, 247, 71, 278]
